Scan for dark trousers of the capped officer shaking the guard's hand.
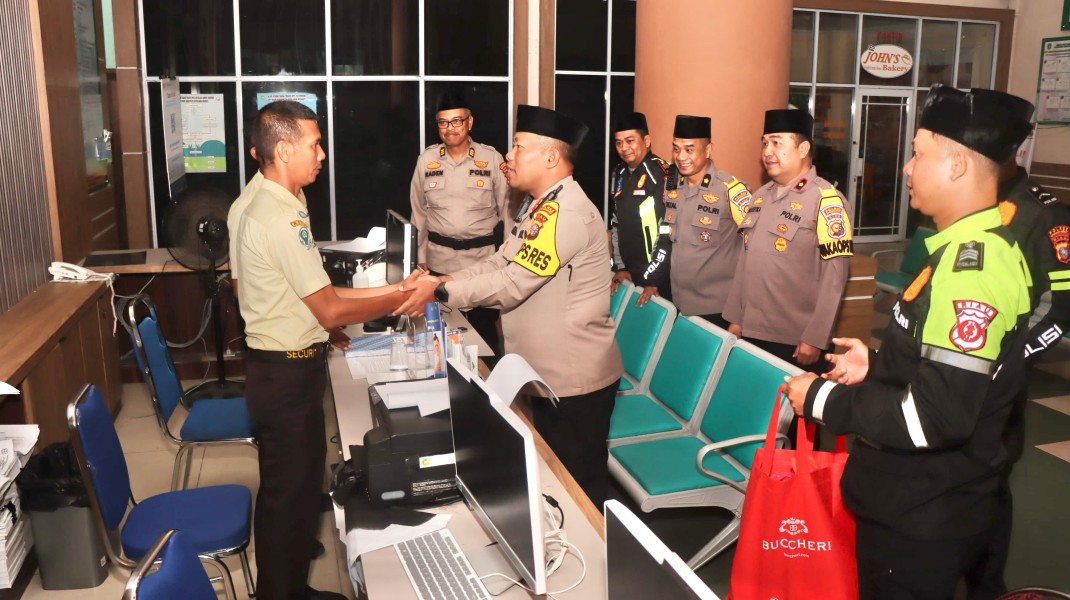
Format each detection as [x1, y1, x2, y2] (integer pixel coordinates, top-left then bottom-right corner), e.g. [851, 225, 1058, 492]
[532, 380, 621, 510]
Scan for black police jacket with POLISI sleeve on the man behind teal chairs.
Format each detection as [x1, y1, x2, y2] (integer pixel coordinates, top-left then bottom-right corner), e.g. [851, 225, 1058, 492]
[610, 152, 669, 296]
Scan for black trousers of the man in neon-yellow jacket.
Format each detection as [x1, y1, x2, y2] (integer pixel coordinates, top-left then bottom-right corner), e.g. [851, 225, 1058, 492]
[855, 520, 988, 600]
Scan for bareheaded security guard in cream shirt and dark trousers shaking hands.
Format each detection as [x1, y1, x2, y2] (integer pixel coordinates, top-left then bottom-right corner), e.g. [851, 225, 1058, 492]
[235, 102, 411, 600]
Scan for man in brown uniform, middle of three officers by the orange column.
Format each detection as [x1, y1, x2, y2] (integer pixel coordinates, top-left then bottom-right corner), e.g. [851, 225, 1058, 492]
[637, 114, 750, 327]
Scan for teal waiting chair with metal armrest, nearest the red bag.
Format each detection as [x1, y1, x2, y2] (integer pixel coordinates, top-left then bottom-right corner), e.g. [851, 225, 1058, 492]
[609, 341, 803, 569]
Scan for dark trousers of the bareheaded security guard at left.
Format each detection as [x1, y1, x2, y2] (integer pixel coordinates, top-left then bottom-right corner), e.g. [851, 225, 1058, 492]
[245, 352, 326, 600]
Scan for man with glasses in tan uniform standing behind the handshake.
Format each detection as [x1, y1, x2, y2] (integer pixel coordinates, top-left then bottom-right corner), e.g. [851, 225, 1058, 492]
[409, 90, 509, 353]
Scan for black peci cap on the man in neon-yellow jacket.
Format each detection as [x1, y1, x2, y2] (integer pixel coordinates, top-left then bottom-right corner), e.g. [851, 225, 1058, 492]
[918, 83, 1033, 165]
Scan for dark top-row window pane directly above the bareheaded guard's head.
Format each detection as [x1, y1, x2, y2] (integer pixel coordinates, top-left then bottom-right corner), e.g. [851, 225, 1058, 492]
[240, 0, 326, 75]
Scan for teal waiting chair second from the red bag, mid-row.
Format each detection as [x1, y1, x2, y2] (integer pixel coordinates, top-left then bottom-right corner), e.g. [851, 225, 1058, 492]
[609, 316, 736, 446]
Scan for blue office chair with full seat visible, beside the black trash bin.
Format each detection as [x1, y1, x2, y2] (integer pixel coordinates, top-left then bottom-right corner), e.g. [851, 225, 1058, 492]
[67, 385, 256, 598]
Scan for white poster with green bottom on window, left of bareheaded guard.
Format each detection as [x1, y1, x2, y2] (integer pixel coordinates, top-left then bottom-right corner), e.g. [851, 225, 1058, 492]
[182, 94, 227, 173]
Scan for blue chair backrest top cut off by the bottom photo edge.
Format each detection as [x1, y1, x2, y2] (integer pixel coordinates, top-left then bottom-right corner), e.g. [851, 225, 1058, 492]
[123, 529, 217, 600]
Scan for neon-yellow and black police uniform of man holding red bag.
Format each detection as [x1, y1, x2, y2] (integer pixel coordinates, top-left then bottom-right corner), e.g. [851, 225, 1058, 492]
[805, 207, 1029, 598]
